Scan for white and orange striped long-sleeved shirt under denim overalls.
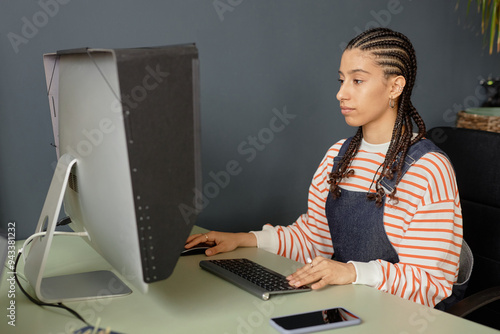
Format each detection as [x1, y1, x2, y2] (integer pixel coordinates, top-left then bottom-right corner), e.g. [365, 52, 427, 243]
[253, 140, 462, 307]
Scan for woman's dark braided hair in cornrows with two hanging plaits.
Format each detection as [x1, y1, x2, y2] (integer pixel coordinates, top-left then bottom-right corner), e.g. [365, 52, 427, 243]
[328, 28, 425, 207]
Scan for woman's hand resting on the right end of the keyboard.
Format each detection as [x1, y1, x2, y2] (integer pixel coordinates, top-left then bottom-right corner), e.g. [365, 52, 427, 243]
[287, 256, 356, 290]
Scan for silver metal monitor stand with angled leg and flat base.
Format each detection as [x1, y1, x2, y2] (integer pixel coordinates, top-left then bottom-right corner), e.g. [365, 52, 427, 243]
[23, 154, 132, 303]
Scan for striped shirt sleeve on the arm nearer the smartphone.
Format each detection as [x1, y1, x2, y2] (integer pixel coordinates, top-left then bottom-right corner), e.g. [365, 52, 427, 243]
[353, 153, 463, 307]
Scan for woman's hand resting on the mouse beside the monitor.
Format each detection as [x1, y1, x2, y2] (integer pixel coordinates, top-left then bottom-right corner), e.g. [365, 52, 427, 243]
[184, 231, 257, 256]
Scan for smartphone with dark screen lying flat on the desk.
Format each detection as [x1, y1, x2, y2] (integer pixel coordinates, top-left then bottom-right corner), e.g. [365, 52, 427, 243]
[269, 307, 361, 334]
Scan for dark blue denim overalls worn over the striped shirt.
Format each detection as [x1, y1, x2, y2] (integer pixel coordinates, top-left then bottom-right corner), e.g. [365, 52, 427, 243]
[325, 138, 463, 308]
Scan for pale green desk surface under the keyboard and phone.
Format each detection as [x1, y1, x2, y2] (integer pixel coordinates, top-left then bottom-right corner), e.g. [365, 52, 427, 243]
[0, 227, 497, 334]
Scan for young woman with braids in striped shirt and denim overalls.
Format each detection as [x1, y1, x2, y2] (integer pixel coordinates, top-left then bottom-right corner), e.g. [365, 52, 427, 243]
[186, 28, 462, 307]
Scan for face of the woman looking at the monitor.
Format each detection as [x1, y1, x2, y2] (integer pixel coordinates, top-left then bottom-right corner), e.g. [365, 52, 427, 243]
[337, 49, 397, 144]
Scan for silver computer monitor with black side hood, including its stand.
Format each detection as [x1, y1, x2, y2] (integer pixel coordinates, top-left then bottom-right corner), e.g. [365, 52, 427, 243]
[24, 44, 201, 303]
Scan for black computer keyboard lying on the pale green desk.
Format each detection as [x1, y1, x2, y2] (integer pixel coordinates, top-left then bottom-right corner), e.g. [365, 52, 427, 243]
[200, 259, 311, 300]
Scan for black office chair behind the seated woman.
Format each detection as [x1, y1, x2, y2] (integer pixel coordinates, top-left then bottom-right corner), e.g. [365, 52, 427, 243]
[427, 127, 500, 329]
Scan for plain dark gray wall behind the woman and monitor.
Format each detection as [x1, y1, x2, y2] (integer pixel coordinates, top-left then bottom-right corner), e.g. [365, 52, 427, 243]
[0, 0, 500, 238]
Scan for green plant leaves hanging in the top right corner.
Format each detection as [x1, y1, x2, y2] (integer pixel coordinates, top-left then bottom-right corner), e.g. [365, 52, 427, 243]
[457, 0, 500, 54]
